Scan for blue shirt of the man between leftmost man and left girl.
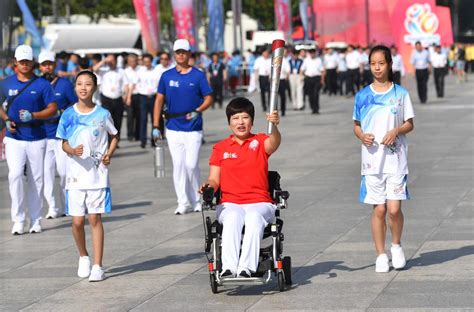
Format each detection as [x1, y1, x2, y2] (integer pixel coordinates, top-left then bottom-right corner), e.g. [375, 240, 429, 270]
[44, 77, 77, 139]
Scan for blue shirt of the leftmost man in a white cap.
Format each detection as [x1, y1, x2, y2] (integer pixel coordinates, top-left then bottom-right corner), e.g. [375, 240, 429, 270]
[0, 75, 56, 141]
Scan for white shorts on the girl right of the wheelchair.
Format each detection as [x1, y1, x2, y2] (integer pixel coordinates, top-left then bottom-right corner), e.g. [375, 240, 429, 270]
[359, 173, 410, 205]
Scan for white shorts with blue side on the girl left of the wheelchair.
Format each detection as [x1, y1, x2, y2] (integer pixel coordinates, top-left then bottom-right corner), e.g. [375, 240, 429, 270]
[66, 187, 112, 217]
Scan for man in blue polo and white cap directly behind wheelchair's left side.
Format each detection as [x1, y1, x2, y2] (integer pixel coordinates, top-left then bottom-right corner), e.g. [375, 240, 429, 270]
[153, 39, 212, 215]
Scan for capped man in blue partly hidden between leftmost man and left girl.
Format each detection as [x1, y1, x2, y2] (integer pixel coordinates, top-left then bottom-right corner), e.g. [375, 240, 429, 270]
[38, 51, 77, 219]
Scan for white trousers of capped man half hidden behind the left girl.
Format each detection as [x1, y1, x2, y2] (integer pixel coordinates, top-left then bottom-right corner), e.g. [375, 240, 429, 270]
[44, 139, 67, 215]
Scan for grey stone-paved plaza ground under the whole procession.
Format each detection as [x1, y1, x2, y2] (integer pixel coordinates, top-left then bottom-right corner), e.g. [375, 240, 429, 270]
[0, 75, 474, 311]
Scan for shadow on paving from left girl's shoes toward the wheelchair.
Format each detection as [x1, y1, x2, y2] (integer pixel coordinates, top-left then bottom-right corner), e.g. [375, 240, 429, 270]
[107, 252, 203, 277]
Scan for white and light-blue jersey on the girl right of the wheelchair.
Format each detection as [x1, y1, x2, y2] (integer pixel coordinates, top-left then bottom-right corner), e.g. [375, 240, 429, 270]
[352, 84, 415, 175]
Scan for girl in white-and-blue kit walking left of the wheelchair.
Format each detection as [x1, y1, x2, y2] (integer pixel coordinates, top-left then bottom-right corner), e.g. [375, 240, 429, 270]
[56, 70, 118, 282]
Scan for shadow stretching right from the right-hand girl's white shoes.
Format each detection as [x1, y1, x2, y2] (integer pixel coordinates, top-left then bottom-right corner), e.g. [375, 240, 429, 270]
[405, 245, 474, 270]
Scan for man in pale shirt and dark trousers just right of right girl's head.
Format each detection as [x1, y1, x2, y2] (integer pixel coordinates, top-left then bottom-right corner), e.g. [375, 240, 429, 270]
[411, 41, 431, 104]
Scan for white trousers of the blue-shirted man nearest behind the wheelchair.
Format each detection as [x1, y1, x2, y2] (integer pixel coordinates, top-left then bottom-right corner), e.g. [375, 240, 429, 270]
[166, 129, 202, 207]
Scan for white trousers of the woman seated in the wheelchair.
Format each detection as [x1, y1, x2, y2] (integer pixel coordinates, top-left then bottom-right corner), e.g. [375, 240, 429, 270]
[217, 203, 276, 274]
